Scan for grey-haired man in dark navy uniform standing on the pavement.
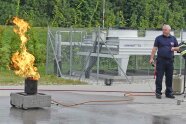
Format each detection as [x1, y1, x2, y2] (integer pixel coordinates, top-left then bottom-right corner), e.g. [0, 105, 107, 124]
[149, 25, 179, 99]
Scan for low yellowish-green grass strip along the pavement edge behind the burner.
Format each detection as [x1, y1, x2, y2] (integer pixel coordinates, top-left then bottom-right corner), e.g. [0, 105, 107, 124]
[0, 65, 86, 86]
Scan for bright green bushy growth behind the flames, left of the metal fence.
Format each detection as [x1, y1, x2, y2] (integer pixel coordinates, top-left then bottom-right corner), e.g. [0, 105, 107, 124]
[0, 26, 47, 69]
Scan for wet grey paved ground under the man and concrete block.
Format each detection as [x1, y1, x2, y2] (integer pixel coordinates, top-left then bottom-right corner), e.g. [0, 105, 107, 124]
[0, 82, 186, 124]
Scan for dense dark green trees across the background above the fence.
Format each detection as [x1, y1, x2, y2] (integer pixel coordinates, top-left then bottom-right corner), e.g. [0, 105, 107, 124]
[0, 0, 186, 29]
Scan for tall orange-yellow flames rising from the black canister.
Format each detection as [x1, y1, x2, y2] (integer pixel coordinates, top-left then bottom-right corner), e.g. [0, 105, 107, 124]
[11, 17, 40, 80]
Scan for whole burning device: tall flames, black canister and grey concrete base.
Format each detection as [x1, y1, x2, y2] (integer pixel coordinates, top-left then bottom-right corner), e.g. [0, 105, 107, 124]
[10, 17, 51, 109]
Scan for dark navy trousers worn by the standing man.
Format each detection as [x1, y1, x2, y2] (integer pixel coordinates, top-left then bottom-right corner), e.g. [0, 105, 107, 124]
[156, 57, 174, 95]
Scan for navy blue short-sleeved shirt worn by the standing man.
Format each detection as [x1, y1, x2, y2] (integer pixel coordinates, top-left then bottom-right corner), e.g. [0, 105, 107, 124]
[154, 35, 178, 59]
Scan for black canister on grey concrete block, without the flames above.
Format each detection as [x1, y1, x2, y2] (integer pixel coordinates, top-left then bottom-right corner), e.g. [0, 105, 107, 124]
[10, 78, 51, 109]
